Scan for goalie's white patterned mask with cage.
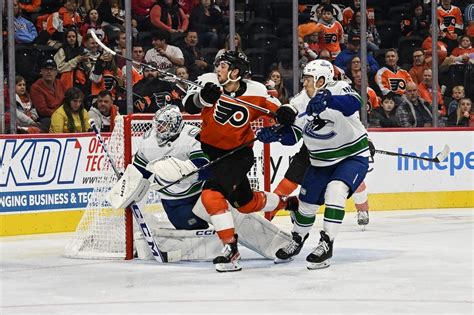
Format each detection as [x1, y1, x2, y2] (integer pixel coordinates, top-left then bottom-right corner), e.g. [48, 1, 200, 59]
[153, 105, 184, 146]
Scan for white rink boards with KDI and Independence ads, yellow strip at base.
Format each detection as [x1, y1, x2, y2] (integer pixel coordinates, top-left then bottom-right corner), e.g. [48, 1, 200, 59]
[0, 128, 474, 235]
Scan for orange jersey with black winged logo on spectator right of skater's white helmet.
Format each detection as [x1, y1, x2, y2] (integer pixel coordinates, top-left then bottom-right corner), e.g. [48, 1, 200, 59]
[375, 67, 413, 95]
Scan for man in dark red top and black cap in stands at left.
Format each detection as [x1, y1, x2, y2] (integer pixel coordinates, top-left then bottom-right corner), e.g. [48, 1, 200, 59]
[30, 59, 66, 129]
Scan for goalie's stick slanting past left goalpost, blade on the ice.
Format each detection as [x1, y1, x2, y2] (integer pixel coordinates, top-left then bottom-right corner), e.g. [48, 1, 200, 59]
[89, 119, 176, 263]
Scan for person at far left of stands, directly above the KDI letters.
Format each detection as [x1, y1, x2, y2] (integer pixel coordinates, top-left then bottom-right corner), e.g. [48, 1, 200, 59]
[15, 76, 43, 133]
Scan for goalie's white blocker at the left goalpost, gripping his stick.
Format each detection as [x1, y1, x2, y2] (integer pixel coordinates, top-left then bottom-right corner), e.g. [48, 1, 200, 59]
[107, 164, 150, 209]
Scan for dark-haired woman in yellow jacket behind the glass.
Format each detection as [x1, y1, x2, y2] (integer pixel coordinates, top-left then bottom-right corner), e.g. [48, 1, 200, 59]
[49, 87, 90, 133]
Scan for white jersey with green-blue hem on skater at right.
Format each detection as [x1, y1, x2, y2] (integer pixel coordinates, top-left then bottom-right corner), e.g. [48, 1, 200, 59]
[295, 81, 370, 167]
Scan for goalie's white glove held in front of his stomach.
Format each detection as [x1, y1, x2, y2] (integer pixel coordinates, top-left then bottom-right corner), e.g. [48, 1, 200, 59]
[146, 157, 198, 183]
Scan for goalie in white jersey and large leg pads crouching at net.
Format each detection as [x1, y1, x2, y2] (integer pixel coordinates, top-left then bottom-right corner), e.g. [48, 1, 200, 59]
[112, 106, 291, 260]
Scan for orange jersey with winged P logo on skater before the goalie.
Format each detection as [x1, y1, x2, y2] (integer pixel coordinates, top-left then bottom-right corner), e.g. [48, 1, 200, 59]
[183, 73, 280, 150]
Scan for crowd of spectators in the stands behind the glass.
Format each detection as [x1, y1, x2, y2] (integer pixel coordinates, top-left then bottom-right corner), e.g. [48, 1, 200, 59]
[3, 0, 474, 133]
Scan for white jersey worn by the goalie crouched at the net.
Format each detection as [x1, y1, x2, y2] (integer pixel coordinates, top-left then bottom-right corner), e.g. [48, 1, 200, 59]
[133, 125, 209, 200]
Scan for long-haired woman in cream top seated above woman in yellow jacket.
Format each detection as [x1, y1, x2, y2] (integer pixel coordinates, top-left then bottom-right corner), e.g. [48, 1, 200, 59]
[54, 29, 89, 90]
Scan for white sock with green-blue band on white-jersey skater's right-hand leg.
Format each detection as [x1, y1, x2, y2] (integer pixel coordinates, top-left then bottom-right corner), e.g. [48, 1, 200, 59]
[323, 181, 349, 241]
